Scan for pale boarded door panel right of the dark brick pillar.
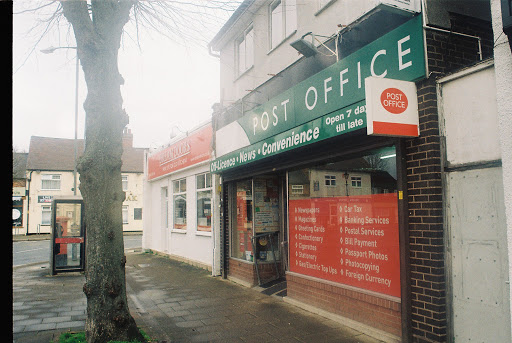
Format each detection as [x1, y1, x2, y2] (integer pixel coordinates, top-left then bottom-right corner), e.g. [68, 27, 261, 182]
[447, 168, 510, 342]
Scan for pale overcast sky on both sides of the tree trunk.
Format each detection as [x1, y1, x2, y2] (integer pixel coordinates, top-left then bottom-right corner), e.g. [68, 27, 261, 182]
[12, 1, 231, 151]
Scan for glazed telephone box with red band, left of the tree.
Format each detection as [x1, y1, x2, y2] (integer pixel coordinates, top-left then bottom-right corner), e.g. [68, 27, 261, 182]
[50, 196, 85, 275]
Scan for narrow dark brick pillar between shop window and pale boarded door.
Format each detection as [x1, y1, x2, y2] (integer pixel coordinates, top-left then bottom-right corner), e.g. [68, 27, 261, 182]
[406, 79, 447, 342]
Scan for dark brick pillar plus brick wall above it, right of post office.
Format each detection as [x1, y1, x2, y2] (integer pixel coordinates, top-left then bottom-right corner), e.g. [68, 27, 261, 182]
[406, 15, 493, 342]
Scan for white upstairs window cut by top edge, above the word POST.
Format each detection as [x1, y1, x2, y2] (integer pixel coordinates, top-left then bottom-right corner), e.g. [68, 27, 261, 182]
[270, 0, 297, 49]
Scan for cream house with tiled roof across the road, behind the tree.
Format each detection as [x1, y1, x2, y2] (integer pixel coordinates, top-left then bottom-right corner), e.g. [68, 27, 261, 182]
[21, 130, 145, 235]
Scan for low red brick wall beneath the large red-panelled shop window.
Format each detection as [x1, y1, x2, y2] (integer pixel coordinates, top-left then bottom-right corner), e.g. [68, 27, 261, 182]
[286, 274, 402, 337]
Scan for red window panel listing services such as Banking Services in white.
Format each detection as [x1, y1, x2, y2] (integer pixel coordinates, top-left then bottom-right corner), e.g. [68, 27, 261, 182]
[289, 193, 400, 297]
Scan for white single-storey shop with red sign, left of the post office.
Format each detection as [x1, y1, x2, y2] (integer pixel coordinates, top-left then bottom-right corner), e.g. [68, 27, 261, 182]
[142, 124, 218, 275]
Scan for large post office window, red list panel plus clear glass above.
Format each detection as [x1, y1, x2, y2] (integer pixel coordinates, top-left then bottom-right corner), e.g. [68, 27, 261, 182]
[288, 147, 401, 298]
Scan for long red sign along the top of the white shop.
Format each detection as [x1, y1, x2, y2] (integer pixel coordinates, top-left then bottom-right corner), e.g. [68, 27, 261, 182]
[148, 125, 213, 180]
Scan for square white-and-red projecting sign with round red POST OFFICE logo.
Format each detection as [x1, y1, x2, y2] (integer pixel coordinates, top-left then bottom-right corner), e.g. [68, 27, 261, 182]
[365, 76, 419, 137]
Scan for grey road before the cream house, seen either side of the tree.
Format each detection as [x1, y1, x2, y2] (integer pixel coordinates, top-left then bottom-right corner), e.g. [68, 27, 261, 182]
[12, 234, 142, 267]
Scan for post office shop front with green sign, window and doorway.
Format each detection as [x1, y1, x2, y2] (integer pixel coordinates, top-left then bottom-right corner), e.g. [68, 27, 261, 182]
[210, 16, 426, 341]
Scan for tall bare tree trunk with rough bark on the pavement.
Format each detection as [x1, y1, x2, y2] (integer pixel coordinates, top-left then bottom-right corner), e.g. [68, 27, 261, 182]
[61, 0, 144, 343]
